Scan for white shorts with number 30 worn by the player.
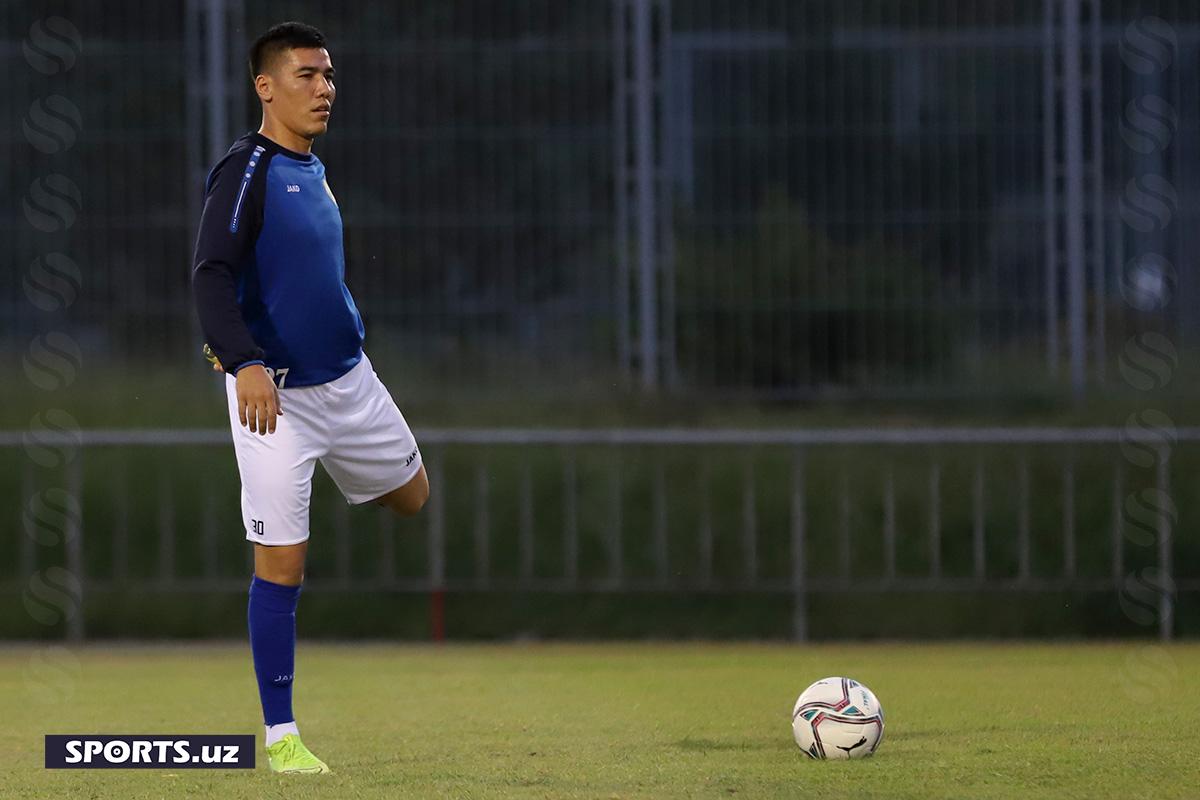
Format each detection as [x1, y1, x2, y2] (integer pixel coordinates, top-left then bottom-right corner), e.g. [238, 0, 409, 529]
[226, 353, 421, 545]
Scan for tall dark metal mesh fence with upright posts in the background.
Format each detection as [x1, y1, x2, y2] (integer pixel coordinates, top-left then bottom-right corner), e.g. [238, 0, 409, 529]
[0, 0, 1200, 396]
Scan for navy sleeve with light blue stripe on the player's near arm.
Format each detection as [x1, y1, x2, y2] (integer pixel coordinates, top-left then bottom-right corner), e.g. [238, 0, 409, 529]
[192, 148, 266, 374]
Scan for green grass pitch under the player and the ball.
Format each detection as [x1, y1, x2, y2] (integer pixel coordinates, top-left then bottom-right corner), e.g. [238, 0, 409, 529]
[0, 643, 1200, 800]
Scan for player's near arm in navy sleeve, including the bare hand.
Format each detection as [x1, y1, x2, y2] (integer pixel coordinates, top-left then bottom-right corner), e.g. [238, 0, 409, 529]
[192, 150, 283, 434]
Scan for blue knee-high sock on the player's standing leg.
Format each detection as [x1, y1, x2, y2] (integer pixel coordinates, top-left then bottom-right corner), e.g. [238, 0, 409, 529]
[246, 576, 300, 724]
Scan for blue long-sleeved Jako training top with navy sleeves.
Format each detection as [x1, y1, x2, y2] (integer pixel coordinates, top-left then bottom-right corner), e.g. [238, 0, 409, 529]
[192, 133, 364, 387]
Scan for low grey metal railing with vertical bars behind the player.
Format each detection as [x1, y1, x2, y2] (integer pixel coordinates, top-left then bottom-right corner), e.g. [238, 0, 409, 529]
[0, 428, 1200, 639]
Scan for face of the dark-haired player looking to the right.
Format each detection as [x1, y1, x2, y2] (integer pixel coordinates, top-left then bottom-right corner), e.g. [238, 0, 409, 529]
[256, 47, 337, 139]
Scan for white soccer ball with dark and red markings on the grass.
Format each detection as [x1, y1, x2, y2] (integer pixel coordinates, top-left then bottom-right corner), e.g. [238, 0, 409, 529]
[792, 678, 883, 758]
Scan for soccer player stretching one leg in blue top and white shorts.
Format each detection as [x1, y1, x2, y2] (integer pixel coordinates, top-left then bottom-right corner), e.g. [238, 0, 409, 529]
[192, 23, 430, 772]
